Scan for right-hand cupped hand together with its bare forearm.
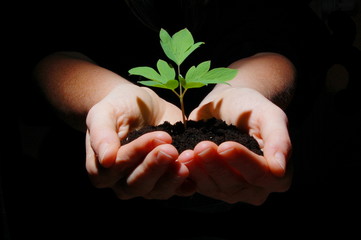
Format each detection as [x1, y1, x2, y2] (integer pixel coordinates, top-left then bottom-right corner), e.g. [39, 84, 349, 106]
[179, 53, 295, 205]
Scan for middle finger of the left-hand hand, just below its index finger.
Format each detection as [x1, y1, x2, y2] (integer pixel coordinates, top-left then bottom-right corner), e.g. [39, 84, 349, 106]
[118, 144, 178, 197]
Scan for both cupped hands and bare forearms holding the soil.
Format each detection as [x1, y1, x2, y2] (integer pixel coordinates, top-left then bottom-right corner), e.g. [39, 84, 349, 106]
[35, 52, 294, 205]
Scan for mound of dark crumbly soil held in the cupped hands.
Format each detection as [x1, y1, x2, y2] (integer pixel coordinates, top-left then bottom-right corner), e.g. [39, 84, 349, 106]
[122, 118, 263, 155]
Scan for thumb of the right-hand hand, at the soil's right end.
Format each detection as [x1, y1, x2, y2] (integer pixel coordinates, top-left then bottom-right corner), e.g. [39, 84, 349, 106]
[261, 110, 292, 177]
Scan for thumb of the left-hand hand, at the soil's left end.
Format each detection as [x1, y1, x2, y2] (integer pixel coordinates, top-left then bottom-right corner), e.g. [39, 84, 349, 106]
[87, 106, 120, 167]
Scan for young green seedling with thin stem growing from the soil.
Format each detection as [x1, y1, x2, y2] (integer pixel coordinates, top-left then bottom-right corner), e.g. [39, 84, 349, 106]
[129, 28, 237, 126]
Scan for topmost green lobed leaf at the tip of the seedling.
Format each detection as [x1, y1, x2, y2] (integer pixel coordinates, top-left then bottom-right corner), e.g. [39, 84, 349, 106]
[159, 28, 203, 66]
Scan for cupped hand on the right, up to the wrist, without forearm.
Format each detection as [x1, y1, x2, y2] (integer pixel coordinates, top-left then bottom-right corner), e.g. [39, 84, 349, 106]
[179, 88, 292, 205]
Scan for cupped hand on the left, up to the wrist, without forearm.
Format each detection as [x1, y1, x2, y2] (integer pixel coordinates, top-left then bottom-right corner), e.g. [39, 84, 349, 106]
[86, 84, 193, 199]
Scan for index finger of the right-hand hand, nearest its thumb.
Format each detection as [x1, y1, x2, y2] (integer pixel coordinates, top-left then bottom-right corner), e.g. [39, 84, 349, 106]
[218, 142, 269, 186]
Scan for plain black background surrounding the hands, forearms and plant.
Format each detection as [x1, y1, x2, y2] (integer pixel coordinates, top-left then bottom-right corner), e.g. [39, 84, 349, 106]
[0, 1, 361, 239]
